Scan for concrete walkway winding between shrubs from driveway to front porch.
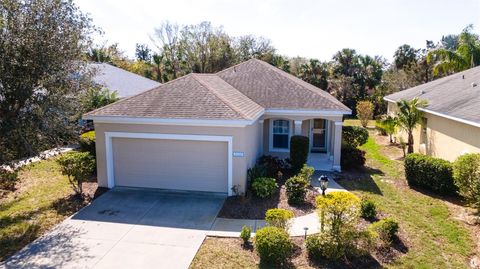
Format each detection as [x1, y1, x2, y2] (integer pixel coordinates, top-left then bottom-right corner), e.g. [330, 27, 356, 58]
[207, 176, 347, 237]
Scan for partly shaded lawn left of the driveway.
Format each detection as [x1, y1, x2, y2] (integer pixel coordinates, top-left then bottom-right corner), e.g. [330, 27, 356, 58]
[0, 159, 96, 260]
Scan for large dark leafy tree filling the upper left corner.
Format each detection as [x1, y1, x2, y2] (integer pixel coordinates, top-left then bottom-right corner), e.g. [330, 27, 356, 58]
[0, 0, 95, 162]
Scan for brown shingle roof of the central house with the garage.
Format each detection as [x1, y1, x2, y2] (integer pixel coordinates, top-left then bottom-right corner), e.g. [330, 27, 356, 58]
[85, 60, 351, 121]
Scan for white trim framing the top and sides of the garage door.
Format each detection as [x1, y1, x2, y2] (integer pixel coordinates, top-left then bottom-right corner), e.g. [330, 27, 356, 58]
[105, 132, 233, 196]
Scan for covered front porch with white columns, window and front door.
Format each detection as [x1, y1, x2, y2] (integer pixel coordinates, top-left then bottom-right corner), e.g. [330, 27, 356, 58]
[259, 115, 342, 171]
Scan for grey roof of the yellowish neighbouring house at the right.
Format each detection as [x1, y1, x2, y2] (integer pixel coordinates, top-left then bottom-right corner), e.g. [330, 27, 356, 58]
[384, 66, 480, 126]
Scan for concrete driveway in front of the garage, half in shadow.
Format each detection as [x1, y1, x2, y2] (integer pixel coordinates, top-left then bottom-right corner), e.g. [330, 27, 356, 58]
[3, 189, 224, 268]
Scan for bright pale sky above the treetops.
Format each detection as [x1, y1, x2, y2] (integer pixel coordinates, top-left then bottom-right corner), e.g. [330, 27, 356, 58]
[76, 0, 480, 61]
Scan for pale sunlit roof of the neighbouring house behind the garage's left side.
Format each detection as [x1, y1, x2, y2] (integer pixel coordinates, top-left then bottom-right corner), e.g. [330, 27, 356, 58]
[89, 63, 161, 98]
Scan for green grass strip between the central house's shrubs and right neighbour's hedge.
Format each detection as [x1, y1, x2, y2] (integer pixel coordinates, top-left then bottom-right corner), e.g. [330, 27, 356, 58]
[341, 138, 474, 269]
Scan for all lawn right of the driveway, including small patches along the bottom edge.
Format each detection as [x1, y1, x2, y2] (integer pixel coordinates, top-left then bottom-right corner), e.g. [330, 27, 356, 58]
[190, 131, 475, 269]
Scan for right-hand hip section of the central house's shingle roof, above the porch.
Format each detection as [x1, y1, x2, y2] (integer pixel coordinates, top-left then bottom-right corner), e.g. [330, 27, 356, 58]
[217, 59, 351, 112]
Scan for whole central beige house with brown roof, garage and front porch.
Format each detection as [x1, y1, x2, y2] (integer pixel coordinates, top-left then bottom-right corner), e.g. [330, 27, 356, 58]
[84, 60, 351, 195]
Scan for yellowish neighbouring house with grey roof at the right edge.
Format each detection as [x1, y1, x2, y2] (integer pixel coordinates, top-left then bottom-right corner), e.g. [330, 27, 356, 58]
[384, 67, 480, 161]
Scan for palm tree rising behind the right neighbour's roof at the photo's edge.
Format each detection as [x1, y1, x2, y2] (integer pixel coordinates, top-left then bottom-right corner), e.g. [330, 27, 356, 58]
[427, 25, 480, 76]
